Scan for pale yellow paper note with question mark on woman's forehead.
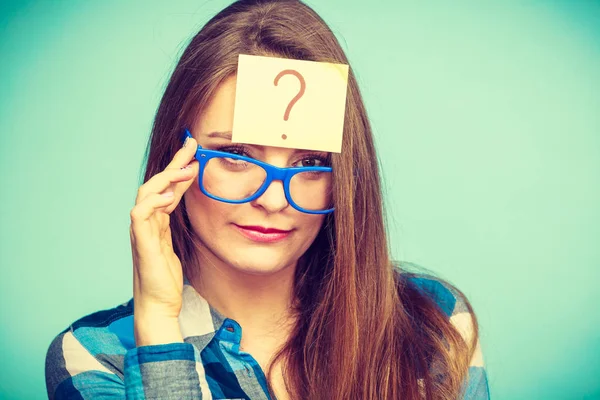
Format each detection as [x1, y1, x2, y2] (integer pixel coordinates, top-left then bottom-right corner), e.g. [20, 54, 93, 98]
[232, 54, 348, 153]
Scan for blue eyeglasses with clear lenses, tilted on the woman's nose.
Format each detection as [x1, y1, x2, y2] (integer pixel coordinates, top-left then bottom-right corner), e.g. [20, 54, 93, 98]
[182, 129, 334, 214]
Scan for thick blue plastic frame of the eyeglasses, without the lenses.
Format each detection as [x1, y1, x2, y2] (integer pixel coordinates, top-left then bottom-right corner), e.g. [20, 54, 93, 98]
[182, 129, 335, 214]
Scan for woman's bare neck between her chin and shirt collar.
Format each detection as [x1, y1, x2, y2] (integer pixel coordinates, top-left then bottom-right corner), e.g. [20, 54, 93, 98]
[190, 252, 297, 336]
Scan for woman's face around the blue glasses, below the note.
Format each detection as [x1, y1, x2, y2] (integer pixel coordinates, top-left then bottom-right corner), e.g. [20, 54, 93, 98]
[184, 76, 327, 274]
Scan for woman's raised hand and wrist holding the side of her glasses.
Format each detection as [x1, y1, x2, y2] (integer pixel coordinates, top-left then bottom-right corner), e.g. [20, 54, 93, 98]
[129, 134, 198, 335]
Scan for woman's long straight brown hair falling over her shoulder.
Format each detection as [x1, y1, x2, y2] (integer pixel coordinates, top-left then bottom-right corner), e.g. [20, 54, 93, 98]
[144, 0, 478, 400]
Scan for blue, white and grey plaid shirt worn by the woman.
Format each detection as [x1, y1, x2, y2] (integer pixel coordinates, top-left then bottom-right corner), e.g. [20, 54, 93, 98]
[46, 277, 489, 400]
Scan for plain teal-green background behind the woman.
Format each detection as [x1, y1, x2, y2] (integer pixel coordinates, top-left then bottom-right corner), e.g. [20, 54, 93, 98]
[0, 0, 600, 399]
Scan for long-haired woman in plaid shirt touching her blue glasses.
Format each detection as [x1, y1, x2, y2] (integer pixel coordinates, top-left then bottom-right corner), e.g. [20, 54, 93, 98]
[46, 0, 488, 400]
